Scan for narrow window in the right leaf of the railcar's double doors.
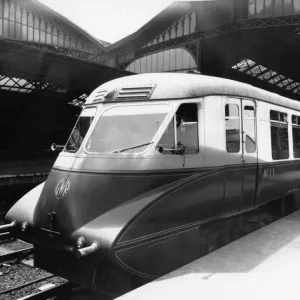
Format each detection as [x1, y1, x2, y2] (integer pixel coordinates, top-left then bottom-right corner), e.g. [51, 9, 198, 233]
[243, 105, 256, 153]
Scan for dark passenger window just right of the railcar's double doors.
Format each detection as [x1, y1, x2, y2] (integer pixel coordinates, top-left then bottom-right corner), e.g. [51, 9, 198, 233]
[270, 110, 289, 160]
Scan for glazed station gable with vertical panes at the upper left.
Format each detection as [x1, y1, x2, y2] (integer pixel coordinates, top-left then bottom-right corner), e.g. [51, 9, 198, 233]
[0, 0, 104, 63]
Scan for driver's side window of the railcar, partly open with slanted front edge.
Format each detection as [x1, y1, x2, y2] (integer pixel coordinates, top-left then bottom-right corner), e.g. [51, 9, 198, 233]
[158, 103, 199, 154]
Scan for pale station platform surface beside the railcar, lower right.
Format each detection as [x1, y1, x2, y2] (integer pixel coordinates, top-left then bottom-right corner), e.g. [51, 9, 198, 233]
[117, 210, 300, 300]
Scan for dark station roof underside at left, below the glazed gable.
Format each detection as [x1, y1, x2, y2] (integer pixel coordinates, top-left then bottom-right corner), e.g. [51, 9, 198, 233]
[0, 40, 132, 93]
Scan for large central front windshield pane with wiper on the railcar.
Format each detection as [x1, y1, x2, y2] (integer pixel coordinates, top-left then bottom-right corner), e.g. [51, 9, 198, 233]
[86, 104, 170, 153]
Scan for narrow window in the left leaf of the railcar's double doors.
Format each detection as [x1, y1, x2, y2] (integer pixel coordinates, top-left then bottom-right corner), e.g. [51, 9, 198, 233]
[225, 103, 240, 153]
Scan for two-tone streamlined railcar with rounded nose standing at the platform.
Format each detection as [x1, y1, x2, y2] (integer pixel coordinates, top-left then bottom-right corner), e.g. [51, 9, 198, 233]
[1, 73, 300, 295]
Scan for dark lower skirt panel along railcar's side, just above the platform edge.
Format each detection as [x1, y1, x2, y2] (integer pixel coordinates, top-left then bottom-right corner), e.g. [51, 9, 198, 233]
[115, 193, 300, 280]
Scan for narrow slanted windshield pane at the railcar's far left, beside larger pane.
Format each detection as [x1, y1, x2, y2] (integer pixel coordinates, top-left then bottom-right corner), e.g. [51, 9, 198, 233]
[65, 107, 96, 152]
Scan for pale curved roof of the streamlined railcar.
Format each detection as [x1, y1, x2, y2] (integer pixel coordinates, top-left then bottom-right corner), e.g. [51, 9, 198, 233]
[86, 73, 300, 111]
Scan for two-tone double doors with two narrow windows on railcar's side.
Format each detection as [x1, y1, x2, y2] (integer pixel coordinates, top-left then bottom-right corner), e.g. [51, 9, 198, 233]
[222, 98, 257, 212]
